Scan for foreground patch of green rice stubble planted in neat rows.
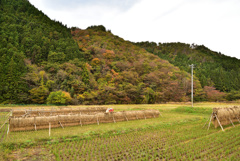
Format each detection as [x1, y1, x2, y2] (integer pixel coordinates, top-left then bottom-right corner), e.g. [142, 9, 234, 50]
[41, 121, 240, 160]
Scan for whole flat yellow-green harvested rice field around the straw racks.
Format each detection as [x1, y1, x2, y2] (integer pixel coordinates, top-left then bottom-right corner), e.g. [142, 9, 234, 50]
[0, 103, 240, 161]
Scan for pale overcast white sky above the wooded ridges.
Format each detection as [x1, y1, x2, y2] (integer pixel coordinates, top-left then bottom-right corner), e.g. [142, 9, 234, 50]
[29, 0, 240, 59]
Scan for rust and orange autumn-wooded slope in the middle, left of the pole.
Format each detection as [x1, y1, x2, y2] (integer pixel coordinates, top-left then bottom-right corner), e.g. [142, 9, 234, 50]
[69, 26, 202, 103]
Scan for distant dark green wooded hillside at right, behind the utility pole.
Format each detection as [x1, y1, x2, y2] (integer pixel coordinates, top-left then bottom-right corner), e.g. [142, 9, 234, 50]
[135, 42, 240, 100]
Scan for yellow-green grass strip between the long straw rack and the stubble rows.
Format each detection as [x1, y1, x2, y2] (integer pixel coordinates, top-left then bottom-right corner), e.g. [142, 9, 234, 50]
[4, 112, 206, 143]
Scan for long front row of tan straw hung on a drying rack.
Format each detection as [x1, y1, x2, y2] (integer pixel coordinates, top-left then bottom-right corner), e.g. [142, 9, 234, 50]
[9, 110, 160, 131]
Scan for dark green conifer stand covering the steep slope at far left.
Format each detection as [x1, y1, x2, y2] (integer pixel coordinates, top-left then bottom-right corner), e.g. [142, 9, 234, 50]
[0, 0, 81, 103]
